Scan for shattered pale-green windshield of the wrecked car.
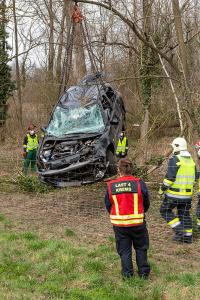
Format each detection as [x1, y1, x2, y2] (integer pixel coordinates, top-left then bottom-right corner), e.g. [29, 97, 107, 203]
[46, 104, 105, 137]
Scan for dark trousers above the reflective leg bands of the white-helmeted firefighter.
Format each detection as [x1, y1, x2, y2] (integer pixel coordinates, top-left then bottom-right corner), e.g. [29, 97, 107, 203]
[160, 196, 192, 231]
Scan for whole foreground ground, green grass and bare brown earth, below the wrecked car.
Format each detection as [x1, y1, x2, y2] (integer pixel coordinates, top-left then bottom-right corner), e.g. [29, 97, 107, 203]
[0, 146, 200, 300]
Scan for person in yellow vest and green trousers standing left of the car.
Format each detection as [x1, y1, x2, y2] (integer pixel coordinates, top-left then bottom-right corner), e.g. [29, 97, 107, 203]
[23, 124, 39, 175]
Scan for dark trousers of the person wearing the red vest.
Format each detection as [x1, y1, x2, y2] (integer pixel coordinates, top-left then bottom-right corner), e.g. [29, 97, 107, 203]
[113, 224, 150, 277]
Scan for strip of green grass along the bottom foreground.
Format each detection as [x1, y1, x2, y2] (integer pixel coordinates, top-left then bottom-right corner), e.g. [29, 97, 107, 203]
[0, 215, 200, 300]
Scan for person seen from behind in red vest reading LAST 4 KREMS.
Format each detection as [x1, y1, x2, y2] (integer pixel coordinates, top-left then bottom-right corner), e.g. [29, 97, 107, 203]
[105, 158, 150, 278]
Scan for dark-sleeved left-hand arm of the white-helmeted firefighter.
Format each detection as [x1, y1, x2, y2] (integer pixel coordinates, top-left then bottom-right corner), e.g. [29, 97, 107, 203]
[161, 155, 180, 192]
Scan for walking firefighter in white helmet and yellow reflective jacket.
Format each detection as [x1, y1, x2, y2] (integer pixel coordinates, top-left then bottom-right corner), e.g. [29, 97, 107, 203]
[159, 137, 196, 243]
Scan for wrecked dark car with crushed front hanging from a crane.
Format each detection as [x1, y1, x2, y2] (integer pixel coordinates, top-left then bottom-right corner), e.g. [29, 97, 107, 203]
[37, 75, 125, 187]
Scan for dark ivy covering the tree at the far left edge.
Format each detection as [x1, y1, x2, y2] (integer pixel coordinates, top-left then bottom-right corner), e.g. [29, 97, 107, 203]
[0, 0, 15, 126]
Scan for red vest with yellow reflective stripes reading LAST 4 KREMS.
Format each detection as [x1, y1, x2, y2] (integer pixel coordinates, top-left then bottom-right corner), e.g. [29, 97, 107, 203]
[108, 176, 144, 227]
